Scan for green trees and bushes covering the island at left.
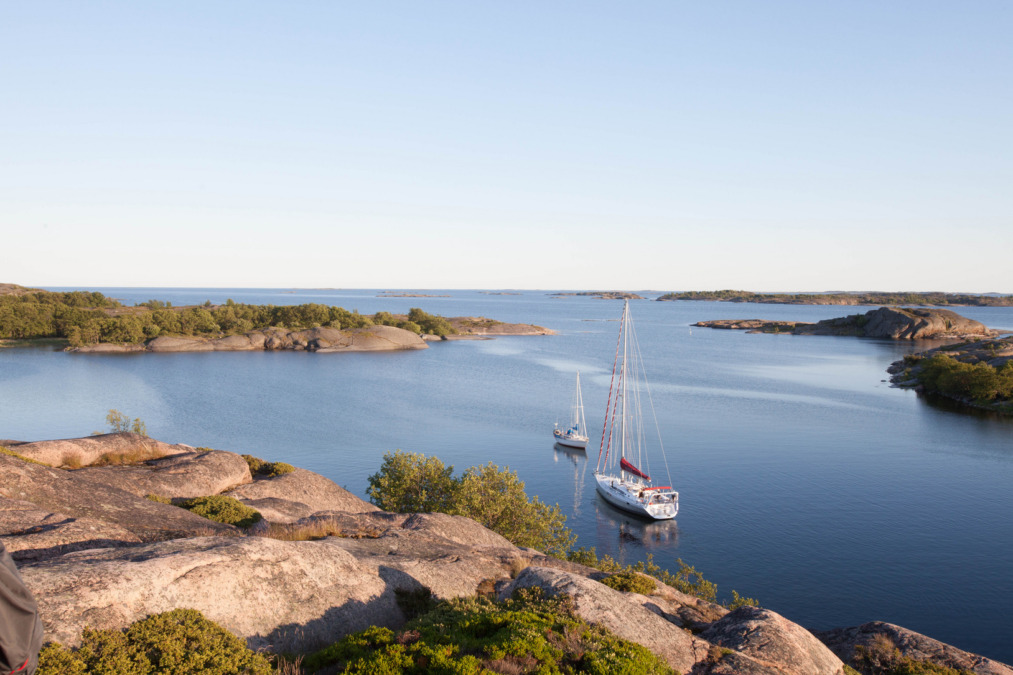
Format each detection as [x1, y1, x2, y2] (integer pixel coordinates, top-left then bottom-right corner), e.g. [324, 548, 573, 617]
[0, 291, 455, 347]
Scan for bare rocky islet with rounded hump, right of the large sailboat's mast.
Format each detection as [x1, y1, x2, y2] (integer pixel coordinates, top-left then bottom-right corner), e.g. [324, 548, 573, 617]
[693, 307, 998, 340]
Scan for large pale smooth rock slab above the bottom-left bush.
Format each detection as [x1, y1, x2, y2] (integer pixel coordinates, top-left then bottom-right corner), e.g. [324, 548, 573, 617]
[21, 537, 391, 651]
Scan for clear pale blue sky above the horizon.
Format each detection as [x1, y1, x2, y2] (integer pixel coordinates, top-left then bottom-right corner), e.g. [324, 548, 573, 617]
[0, 0, 1013, 293]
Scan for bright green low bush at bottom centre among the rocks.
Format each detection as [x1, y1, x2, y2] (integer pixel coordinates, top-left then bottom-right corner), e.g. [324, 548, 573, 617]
[304, 589, 674, 675]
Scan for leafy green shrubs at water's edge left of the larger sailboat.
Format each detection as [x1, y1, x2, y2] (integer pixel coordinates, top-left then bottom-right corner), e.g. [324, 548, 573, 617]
[366, 450, 574, 555]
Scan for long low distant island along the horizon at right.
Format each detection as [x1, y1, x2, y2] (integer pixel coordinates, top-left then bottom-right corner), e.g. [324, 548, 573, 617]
[657, 291, 1013, 307]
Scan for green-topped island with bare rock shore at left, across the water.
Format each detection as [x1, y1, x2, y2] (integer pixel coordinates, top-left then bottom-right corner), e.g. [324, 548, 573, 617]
[0, 284, 552, 353]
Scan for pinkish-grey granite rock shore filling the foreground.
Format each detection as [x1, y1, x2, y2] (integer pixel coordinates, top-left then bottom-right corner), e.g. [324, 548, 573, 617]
[0, 433, 1013, 675]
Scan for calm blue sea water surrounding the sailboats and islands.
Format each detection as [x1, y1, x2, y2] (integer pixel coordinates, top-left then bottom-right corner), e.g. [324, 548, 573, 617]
[0, 289, 1013, 663]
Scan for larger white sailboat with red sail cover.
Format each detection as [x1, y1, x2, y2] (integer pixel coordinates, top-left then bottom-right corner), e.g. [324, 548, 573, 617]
[595, 300, 679, 520]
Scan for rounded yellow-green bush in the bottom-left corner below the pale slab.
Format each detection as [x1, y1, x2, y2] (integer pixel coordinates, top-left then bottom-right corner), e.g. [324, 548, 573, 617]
[36, 609, 275, 675]
